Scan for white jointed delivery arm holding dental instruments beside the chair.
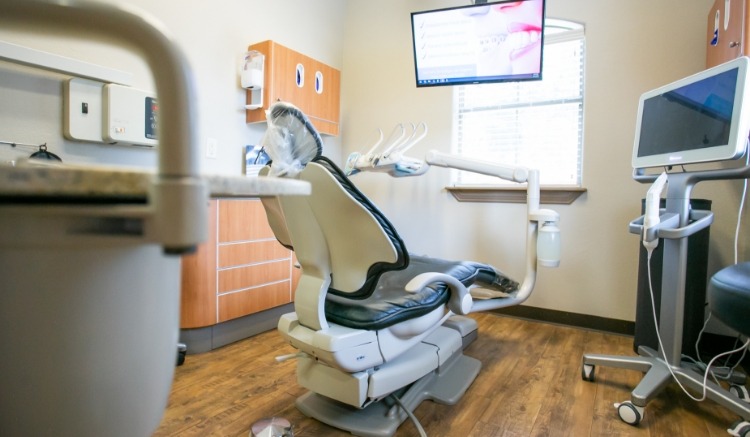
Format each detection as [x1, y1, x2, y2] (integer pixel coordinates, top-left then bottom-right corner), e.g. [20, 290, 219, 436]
[345, 140, 560, 314]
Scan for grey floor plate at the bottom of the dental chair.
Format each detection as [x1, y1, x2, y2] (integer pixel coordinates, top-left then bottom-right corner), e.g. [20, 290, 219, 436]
[296, 351, 482, 437]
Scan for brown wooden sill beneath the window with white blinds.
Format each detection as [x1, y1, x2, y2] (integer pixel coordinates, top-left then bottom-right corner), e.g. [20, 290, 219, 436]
[446, 186, 586, 205]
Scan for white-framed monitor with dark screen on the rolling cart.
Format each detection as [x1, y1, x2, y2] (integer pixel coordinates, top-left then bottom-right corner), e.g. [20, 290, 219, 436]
[632, 57, 750, 168]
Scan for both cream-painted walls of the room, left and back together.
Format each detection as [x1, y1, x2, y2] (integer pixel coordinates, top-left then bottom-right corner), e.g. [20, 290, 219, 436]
[0, 0, 747, 320]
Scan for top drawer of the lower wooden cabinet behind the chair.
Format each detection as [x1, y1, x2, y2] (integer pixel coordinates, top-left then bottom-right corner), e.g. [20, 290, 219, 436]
[218, 199, 274, 243]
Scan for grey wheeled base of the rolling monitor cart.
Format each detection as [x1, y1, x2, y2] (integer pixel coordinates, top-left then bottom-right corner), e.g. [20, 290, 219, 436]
[582, 346, 750, 425]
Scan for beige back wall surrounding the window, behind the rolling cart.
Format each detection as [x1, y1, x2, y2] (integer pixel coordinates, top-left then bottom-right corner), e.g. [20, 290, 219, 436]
[342, 0, 739, 320]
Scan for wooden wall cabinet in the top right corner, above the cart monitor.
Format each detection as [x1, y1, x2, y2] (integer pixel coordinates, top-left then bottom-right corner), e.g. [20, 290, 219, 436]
[706, 0, 750, 68]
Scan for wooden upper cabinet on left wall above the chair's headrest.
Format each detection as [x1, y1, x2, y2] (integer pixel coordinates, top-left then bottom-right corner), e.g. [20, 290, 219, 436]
[246, 41, 341, 135]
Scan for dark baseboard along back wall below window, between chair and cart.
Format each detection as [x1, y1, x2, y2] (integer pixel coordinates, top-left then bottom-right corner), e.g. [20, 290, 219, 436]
[493, 305, 635, 335]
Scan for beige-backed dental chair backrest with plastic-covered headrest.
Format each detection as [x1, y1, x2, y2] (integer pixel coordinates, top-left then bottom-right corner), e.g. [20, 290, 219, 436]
[260, 102, 409, 329]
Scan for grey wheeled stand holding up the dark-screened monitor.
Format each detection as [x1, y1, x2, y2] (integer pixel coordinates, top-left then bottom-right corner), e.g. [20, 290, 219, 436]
[581, 161, 750, 425]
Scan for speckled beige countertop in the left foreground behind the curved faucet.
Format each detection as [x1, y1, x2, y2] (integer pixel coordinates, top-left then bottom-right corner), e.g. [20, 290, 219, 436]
[0, 161, 310, 202]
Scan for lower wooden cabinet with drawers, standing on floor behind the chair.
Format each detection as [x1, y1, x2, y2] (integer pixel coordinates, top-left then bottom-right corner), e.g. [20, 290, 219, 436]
[180, 199, 299, 329]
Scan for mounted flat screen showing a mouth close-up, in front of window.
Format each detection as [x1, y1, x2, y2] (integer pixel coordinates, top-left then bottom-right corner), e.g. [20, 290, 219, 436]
[411, 0, 545, 87]
